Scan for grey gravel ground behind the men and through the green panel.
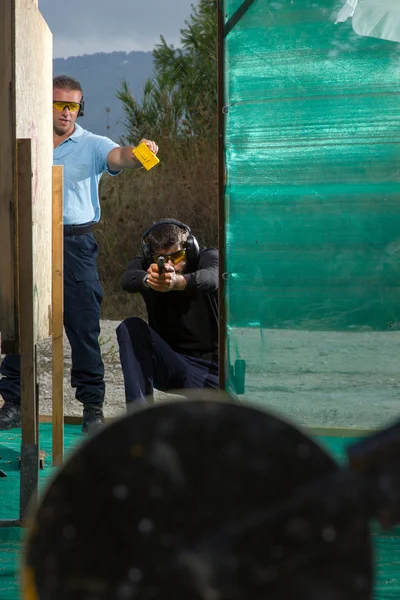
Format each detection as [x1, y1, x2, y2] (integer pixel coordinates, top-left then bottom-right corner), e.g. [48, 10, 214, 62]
[0, 320, 400, 429]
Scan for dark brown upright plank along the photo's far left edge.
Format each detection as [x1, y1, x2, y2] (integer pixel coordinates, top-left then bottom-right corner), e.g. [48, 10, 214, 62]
[0, 0, 18, 354]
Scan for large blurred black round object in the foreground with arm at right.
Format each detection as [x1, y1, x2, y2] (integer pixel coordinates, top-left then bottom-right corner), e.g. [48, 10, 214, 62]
[23, 390, 400, 600]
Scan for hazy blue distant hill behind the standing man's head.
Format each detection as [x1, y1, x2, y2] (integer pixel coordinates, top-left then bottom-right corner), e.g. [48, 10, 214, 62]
[53, 52, 153, 141]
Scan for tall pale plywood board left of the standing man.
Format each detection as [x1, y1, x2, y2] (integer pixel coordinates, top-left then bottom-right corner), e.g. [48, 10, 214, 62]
[14, 0, 53, 342]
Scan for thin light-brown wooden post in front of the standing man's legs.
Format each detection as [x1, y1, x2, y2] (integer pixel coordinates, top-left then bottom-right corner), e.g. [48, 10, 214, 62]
[51, 165, 64, 467]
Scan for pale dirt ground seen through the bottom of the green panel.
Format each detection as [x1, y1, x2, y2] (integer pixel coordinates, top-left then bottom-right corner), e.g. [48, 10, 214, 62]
[229, 328, 400, 429]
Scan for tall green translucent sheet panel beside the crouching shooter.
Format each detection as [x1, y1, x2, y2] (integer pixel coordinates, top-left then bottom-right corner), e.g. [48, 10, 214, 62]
[224, 0, 400, 428]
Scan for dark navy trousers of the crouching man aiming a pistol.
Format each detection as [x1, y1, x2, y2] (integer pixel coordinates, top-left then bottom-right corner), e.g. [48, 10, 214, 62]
[117, 317, 218, 404]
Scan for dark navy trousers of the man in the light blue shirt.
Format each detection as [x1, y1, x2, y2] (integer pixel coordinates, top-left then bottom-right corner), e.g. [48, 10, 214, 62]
[0, 232, 105, 404]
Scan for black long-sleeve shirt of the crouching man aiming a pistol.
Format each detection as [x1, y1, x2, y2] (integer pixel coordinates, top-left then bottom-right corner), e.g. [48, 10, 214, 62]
[121, 248, 218, 356]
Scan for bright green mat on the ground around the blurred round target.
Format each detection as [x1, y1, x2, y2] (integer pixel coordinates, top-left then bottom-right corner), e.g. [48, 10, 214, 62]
[0, 424, 400, 600]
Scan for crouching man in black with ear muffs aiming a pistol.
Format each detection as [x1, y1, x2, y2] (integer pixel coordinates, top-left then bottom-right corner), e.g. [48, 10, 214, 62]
[117, 219, 218, 404]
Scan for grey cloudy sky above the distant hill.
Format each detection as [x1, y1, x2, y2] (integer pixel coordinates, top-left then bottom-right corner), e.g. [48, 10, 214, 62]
[39, 0, 197, 58]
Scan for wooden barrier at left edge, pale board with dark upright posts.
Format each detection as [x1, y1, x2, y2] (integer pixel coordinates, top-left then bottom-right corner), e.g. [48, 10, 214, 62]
[0, 0, 54, 526]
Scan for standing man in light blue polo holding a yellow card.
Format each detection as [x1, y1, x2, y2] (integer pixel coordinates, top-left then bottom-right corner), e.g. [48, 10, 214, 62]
[0, 76, 158, 433]
